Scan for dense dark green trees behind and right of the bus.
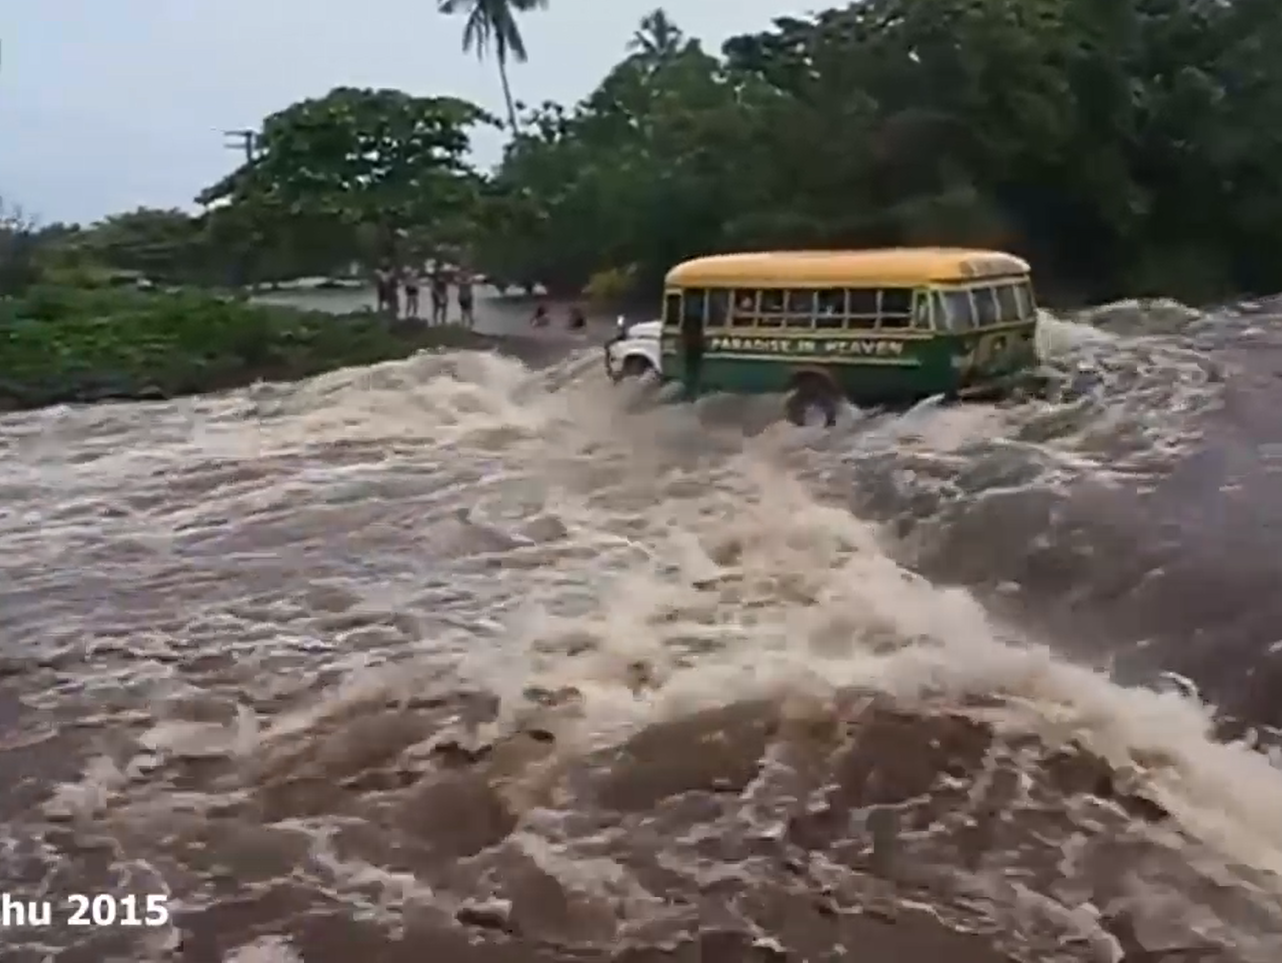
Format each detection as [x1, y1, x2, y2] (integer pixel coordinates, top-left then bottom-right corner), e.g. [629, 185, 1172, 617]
[477, 0, 1282, 297]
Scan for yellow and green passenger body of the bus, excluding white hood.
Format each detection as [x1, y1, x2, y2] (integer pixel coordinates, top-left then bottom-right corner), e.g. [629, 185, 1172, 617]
[659, 247, 1037, 424]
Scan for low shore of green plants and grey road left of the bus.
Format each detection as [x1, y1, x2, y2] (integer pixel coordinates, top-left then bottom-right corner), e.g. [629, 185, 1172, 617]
[0, 280, 604, 413]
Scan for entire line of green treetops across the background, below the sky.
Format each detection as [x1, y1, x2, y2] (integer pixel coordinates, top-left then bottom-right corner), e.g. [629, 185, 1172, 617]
[57, 0, 1282, 305]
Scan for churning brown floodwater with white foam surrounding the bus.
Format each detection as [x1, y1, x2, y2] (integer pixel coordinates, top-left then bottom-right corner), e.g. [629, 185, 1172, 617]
[0, 300, 1282, 963]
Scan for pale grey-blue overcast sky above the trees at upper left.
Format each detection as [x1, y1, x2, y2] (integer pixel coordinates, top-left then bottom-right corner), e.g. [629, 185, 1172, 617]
[0, 0, 799, 223]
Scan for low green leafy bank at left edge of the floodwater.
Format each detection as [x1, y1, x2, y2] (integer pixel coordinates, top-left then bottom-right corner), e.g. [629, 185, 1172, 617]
[0, 286, 505, 410]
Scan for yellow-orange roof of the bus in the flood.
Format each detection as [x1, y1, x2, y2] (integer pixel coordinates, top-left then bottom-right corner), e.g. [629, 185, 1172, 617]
[665, 247, 1029, 287]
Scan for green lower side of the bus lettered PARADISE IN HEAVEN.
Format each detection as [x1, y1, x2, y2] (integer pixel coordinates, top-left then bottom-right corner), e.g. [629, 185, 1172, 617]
[662, 321, 1037, 406]
